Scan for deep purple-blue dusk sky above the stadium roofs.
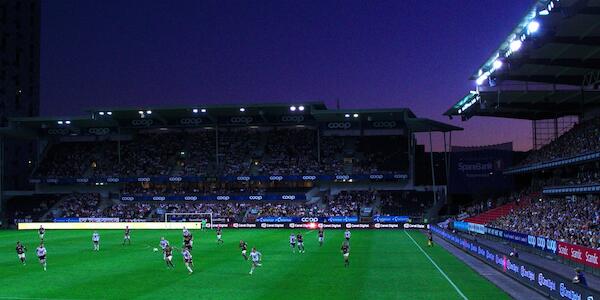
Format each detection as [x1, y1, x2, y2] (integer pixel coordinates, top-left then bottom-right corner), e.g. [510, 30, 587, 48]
[41, 0, 532, 150]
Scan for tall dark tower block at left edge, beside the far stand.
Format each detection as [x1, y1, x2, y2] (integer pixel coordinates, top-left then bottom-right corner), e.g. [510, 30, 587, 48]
[0, 0, 40, 190]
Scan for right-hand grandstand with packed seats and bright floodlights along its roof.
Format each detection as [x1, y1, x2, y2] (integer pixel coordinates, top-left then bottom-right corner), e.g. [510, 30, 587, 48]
[445, 1, 600, 294]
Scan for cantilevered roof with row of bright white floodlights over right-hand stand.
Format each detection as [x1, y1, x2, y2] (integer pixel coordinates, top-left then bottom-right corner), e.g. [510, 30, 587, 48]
[445, 0, 600, 120]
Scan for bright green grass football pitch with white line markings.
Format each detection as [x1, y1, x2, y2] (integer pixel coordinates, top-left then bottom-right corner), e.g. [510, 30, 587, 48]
[0, 229, 509, 299]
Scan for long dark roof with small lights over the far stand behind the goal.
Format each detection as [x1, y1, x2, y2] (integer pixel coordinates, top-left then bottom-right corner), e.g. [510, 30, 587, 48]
[0, 102, 462, 138]
